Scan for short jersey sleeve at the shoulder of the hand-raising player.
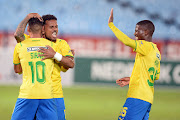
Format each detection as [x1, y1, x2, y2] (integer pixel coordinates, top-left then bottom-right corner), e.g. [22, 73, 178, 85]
[134, 40, 153, 55]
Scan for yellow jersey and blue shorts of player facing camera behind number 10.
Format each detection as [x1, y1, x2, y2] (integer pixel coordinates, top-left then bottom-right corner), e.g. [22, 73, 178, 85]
[24, 34, 73, 120]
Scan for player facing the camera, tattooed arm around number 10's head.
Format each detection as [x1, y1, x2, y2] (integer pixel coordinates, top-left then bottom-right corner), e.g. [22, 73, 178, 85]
[15, 13, 73, 120]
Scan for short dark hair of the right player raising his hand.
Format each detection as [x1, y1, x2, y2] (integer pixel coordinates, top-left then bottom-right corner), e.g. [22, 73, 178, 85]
[136, 20, 155, 36]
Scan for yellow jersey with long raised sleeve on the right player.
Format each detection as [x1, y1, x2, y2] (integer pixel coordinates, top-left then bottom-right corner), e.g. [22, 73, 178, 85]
[109, 22, 161, 104]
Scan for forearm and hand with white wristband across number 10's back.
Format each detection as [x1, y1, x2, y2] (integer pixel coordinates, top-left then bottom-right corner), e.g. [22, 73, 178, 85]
[38, 45, 74, 68]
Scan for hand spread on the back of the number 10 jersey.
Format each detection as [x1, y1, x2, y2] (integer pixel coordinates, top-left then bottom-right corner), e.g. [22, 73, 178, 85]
[38, 45, 56, 61]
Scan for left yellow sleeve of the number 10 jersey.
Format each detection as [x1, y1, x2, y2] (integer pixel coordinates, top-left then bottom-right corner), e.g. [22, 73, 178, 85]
[13, 43, 20, 65]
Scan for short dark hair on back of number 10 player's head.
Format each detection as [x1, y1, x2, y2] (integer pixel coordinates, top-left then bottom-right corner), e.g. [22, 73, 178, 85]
[28, 18, 43, 33]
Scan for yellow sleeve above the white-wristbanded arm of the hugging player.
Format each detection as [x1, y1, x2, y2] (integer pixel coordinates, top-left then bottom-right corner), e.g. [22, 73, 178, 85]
[57, 40, 73, 57]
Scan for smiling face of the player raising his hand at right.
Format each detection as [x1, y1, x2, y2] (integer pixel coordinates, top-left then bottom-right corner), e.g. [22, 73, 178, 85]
[134, 25, 145, 40]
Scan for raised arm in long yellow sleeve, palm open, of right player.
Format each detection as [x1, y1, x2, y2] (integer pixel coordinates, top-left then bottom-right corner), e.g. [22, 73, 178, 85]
[108, 8, 136, 49]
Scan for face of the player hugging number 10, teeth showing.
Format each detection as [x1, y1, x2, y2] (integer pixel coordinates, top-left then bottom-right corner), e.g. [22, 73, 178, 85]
[44, 20, 58, 41]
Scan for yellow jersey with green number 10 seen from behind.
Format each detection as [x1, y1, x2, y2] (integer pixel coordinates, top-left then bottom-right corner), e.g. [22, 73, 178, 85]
[13, 38, 56, 99]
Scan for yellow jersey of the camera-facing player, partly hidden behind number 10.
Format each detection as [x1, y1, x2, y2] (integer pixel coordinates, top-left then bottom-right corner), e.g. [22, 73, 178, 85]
[52, 39, 73, 98]
